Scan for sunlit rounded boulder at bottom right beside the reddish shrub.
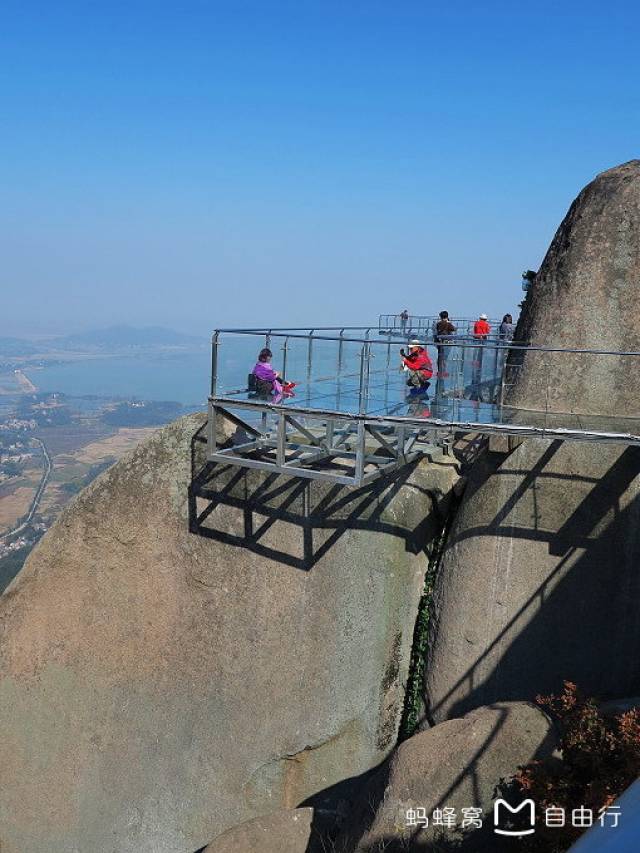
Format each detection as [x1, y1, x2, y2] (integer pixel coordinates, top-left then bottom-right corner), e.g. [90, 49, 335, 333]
[338, 702, 556, 853]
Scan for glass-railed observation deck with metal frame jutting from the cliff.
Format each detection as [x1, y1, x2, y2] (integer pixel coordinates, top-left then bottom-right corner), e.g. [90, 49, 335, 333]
[208, 328, 640, 485]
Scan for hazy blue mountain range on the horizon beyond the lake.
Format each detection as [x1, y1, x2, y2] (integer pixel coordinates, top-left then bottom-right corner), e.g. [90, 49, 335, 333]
[0, 325, 206, 358]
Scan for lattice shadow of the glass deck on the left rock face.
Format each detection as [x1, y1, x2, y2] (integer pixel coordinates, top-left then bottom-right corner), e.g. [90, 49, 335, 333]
[188, 424, 444, 571]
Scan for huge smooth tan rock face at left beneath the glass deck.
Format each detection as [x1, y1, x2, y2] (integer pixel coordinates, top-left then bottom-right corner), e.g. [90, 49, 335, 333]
[0, 416, 456, 853]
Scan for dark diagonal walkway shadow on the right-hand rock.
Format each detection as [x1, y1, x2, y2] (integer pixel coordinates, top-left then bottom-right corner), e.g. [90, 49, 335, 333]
[429, 442, 640, 717]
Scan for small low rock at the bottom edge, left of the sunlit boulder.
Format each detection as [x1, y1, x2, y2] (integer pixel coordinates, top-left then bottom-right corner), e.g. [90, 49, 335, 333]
[204, 808, 313, 853]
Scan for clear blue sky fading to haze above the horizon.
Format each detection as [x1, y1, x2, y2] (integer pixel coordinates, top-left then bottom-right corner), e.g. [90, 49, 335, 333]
[0, 0, 640, 334]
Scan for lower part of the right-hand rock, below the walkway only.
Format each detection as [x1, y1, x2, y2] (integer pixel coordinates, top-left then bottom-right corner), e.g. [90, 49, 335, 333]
[425, 439, 640, 720]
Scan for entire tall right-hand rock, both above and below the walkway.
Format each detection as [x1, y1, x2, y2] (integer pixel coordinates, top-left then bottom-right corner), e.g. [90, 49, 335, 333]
[425, 161, 640, 721]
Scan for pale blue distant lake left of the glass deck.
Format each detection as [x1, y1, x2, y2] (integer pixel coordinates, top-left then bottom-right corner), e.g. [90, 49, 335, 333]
[24, 348, 211, 408]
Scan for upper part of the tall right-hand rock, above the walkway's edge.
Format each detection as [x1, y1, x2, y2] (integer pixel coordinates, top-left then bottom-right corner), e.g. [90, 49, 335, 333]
[508, 160, 640, 416]
